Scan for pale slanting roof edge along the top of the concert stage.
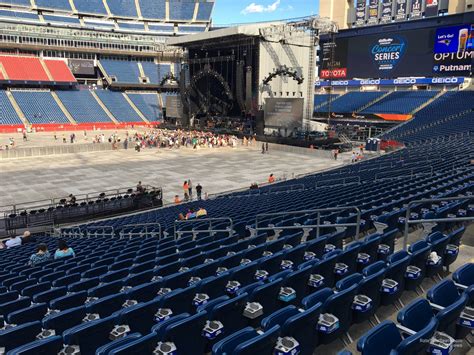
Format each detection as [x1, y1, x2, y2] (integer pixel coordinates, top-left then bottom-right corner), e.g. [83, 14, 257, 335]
[166, 22, 281, 47]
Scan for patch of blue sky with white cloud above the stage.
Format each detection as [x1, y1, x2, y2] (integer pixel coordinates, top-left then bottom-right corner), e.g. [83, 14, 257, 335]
[212, 0, 319, 25]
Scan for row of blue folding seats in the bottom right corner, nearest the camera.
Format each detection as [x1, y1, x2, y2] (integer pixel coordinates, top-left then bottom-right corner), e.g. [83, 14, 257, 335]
[344, 263, 474, 355]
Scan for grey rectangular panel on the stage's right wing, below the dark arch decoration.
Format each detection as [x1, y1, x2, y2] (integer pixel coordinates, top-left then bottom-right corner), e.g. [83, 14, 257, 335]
[265, 98, 304, 129]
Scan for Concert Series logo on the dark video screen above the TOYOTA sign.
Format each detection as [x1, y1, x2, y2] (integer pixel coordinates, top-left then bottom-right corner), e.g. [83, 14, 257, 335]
[370, 37, 406, 71]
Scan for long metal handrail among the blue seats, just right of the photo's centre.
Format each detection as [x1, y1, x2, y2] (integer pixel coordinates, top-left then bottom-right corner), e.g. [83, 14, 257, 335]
[254, 206, 361, 240]
